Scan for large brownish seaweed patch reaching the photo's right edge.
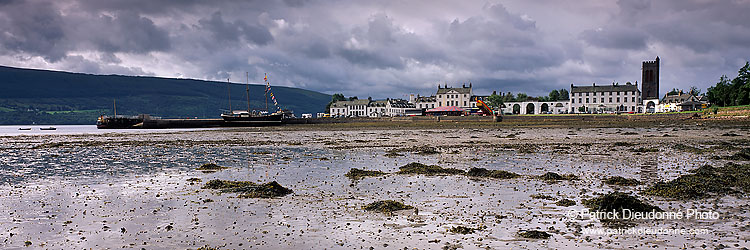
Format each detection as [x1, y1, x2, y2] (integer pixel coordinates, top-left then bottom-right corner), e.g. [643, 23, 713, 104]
[643, 163, 750, 199]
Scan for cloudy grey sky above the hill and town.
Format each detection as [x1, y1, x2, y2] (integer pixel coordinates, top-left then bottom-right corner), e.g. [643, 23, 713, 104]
[0, 0, 750, 99]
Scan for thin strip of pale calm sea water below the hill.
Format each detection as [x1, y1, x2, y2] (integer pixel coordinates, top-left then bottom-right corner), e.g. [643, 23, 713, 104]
[0, 125, 221, 136]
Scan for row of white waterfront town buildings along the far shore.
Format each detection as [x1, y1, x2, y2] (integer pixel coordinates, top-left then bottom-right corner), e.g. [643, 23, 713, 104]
[329, 82, 706, 117]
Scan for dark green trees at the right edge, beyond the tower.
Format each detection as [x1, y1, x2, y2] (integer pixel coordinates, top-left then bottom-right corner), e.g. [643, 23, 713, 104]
[706, 62, 750, 107]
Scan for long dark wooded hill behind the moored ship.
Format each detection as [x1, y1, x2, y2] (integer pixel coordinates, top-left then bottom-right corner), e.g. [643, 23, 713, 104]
[0, 66, 331, 125]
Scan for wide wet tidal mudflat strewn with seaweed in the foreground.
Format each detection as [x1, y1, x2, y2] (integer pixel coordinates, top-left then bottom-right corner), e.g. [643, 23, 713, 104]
[0, 124, 750, 249]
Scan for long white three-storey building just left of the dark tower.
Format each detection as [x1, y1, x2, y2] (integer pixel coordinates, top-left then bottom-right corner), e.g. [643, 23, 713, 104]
[569, 82, 643, 113]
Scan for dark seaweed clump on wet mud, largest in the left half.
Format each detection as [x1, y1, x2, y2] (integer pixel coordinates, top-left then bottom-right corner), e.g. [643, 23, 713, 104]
[203, 180, 293, 198]
